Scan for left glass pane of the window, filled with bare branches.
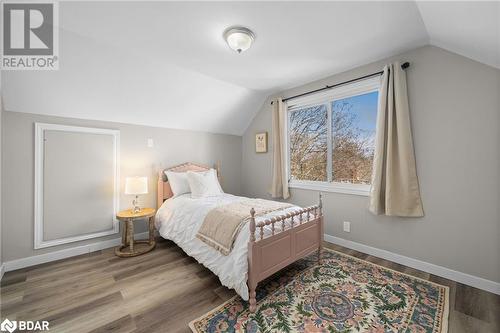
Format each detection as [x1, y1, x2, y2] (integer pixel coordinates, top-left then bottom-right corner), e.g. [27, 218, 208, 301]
[289, 105, 327, 181]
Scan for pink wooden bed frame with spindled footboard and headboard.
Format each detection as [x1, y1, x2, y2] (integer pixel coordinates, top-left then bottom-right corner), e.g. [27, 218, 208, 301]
[158, 163, 323, 312]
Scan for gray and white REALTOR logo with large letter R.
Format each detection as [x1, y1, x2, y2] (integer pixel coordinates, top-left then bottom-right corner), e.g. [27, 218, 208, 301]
[1, 2, 59, 70]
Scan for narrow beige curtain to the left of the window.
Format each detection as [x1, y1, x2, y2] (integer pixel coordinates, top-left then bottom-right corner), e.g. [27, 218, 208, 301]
[270, 98, 290, 199]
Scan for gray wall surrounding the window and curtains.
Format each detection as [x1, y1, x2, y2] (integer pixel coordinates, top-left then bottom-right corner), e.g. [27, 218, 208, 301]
[243, 46, 500, 282]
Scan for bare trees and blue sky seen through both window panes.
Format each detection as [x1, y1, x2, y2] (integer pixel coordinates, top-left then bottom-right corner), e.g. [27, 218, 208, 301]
[288, 89, 378, 184]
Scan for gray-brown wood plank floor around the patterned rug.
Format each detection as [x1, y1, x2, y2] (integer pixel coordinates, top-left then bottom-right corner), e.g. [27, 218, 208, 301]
[1, 239, 500, 333]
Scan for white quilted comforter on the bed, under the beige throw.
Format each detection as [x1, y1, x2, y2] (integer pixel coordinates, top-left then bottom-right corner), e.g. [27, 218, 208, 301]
[155, 194, 299, 300]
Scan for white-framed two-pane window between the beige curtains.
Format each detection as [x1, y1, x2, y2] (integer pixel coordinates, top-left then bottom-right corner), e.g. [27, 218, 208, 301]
[287, 77, 380, 195]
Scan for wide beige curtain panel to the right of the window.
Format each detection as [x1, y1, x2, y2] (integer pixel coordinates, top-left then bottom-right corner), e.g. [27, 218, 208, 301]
[369, 63, 424, 217]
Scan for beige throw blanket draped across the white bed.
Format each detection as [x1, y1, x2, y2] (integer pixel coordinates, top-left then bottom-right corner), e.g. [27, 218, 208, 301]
[196, 199, 293, 256]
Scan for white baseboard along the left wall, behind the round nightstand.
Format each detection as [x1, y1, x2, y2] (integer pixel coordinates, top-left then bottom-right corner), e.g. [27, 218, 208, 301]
[2, 232, 149, 275]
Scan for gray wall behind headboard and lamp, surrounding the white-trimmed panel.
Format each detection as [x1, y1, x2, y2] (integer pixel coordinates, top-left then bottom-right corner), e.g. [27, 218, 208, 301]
[2, 111, 242, 261]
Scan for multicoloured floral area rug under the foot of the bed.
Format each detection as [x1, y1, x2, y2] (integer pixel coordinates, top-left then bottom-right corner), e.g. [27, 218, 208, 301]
[189, 250, 449, 333]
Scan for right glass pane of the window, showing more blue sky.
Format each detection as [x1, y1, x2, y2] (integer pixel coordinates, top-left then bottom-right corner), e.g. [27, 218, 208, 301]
[332, 92, 378, 184]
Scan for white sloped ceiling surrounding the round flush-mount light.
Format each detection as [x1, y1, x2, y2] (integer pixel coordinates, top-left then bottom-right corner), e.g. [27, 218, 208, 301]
[2, 1, 500, 135]
